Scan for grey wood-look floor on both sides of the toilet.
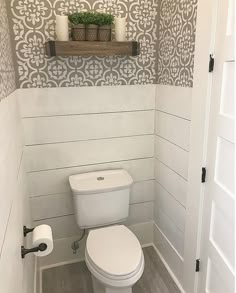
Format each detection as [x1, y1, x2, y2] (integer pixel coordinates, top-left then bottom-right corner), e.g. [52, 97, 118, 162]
[42, 246, 180, 293]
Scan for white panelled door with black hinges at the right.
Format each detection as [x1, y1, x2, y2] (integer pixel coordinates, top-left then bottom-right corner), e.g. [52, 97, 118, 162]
[198, 0, 235, 293]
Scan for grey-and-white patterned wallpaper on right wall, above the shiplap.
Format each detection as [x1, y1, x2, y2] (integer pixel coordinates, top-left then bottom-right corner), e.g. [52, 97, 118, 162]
[157, 0, 197, 87]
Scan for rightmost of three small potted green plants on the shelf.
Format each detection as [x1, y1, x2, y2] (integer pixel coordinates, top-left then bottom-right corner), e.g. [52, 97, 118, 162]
[97, 13, 114, 42]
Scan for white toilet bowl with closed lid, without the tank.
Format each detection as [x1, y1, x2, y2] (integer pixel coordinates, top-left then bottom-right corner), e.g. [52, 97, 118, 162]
[85, 225, 144, 293]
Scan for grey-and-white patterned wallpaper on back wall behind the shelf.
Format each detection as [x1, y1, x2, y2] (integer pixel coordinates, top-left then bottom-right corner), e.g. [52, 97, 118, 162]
[9, 0, 158, 87]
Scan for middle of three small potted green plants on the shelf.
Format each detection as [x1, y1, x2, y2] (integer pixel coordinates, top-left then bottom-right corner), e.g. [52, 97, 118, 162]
[84, 12, 98, 41]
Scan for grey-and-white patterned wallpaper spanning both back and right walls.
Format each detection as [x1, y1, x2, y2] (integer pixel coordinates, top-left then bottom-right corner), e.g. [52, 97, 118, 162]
[7, 0, 197, 87]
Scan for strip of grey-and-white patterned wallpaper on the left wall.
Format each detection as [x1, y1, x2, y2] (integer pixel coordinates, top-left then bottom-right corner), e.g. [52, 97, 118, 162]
[0, 0, 16, 100]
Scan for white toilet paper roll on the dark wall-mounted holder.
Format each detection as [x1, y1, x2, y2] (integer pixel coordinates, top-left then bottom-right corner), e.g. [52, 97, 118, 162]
[32, 225, 53, 256]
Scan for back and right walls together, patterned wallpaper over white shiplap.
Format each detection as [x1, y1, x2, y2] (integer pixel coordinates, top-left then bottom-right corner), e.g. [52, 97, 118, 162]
[4, 0, 197, 283]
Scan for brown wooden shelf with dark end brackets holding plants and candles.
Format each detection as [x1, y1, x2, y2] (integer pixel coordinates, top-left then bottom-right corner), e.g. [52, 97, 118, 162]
[45, 41, 140, 57]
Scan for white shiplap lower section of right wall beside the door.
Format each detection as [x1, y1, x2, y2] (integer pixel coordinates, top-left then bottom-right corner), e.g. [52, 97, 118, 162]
[154, 85, 192, 285]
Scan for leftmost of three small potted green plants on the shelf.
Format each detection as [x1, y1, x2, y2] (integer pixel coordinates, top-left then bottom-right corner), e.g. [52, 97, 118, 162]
[68, 12, 86, 41]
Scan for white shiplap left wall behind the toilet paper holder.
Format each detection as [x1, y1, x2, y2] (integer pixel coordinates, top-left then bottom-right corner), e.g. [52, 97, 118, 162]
[0, 92, 34, 293]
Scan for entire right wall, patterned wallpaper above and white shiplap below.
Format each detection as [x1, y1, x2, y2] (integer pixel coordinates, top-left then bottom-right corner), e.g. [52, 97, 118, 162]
[151, 0, 197, 286]
